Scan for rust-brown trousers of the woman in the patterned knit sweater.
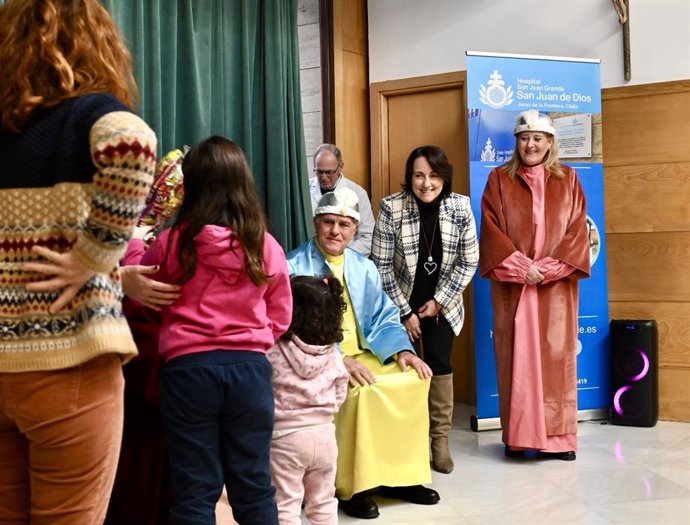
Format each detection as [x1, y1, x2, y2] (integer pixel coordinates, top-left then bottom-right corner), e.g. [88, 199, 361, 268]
[0, 354, 124, 525]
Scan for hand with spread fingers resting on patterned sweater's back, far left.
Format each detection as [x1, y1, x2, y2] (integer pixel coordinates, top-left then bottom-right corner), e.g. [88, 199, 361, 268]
[22, 246, 96, 314]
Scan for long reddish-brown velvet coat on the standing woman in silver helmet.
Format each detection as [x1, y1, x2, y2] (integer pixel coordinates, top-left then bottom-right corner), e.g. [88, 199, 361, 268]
[479, 166, 590, 436]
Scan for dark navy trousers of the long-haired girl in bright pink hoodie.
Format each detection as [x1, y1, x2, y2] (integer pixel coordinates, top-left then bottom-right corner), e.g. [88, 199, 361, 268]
[161, 350, 278, 525]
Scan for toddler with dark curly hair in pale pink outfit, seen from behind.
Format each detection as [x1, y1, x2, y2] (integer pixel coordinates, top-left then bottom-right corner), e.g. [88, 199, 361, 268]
[267, 276, 349, 525]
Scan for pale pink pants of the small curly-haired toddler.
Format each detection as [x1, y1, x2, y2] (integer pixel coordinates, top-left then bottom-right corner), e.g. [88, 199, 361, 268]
[271, 423, 338, 525]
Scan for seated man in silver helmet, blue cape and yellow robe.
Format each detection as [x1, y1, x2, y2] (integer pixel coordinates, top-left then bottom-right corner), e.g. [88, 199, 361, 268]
[288, 188, 439, 518]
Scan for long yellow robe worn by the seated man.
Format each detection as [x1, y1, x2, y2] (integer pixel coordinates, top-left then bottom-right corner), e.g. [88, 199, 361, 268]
[324, 254, 431, 499]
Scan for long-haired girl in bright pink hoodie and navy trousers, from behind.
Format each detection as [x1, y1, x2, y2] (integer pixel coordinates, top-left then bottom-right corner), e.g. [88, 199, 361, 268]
[124, 136, 292, 525]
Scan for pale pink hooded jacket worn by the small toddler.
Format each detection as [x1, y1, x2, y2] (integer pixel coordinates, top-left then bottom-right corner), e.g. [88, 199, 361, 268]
[266, 335, 349, 437]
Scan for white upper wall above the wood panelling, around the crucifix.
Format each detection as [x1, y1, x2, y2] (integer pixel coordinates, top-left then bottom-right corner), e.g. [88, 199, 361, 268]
[368, 0, 690, 88]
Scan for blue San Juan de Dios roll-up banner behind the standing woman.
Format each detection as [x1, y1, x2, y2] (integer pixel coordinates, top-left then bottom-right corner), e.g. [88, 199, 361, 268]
[467, 52, 610, 430]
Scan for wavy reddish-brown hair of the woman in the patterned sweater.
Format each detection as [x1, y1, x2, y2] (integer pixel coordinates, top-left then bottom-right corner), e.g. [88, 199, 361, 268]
[0, 0, 138, 132]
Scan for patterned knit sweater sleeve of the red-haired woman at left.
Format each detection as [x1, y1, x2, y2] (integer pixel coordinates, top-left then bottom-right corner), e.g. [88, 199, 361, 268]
[72, 111, 156, 272]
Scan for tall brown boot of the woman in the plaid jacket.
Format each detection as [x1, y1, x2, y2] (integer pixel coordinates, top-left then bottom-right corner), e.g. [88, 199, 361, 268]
[429, 374, 455, 474]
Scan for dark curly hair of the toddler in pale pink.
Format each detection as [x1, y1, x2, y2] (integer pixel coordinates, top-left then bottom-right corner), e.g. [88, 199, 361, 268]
[283, 275, 346, 345]
